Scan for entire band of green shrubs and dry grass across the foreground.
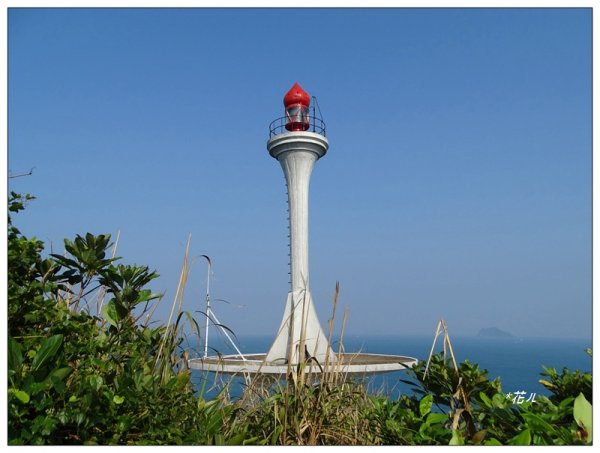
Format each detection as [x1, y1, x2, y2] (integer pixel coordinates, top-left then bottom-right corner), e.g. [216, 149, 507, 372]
[7, 193, 592, 445]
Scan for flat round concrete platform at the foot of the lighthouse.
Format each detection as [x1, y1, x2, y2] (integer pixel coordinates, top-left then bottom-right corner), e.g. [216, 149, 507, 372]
[188, 353, 417, 376]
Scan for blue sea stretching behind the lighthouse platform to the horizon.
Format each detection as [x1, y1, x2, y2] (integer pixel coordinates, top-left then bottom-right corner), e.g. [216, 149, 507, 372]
[190, 335, 592, 399]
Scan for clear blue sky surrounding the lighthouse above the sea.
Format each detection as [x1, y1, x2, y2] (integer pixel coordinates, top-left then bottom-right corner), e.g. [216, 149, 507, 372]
[8, 9, 592, 337]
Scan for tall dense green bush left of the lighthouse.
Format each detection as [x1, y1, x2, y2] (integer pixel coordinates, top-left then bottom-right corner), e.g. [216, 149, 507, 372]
[8, 193, 240, 444]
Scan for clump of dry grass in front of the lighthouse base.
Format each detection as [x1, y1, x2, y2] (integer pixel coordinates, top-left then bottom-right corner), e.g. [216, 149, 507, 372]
[235, 284, 377, 445]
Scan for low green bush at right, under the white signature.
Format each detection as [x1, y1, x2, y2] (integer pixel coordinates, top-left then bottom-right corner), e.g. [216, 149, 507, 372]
[396, 354, 592, 445]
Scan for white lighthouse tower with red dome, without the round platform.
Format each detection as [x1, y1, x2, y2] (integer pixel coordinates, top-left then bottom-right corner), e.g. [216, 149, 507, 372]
[267, 83, 334, 363]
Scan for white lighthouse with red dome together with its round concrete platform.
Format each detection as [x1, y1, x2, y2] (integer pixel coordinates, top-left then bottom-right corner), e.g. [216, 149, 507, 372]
[188, 83, 417, 376]
